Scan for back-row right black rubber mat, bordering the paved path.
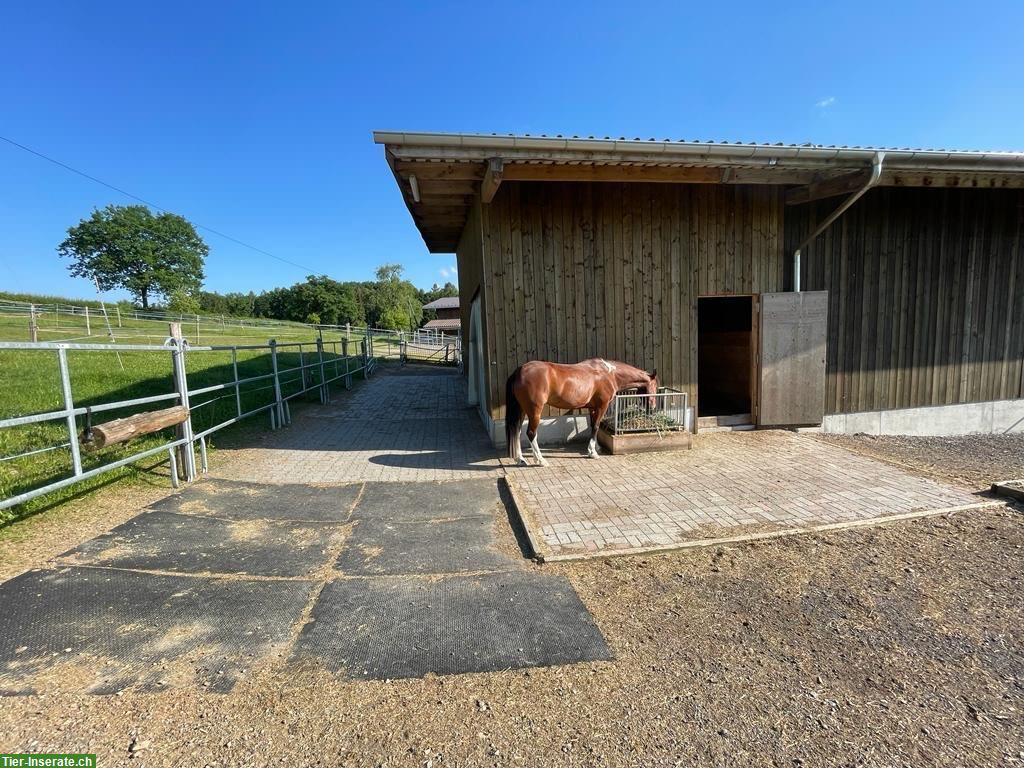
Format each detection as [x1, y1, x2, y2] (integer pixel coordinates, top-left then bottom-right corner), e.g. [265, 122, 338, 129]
[352, 480, 500, 520]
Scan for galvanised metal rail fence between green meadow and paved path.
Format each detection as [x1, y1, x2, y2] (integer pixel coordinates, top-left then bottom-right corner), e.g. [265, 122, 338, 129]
[0, 334, 377, 510]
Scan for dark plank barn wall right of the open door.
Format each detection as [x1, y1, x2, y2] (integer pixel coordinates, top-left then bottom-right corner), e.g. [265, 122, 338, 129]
[785, 187, 1024, 413]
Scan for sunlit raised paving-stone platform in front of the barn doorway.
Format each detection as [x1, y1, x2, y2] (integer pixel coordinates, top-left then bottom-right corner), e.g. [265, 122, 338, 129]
[506, 430, 985, 559]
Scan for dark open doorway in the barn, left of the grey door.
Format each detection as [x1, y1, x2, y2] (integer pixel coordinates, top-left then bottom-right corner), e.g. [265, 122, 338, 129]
[697, 296, 754, 426]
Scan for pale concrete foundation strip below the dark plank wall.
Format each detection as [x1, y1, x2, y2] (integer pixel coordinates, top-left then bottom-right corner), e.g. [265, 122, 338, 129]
[821, 399, 1024, 436]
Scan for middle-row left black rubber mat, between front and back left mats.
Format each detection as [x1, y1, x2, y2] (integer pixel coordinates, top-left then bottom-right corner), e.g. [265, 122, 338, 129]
[61, 512, 342, 577]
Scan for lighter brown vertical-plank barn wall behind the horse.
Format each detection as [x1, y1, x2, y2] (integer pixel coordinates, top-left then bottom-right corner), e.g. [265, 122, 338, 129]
[477, 182, 783, 418]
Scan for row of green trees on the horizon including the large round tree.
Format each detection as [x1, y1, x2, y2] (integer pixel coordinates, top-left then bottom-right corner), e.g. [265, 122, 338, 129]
[57, 205, 459, 330]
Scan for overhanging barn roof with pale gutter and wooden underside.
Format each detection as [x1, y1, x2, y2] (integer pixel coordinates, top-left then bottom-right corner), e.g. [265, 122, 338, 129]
[374, 131, 1024, 253]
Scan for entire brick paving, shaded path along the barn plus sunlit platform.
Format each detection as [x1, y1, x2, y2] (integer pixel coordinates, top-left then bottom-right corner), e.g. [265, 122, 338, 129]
[212, 367, 981, 559]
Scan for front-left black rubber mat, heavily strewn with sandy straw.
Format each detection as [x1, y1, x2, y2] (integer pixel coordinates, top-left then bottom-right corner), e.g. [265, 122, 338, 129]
[0, 567, 313, 695]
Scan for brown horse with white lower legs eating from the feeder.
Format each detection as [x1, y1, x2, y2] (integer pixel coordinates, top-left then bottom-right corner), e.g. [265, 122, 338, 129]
[505, 357, 657, 467]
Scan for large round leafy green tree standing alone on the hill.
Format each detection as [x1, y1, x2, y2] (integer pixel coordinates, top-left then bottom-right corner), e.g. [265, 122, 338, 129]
[57, 205, 210, 309]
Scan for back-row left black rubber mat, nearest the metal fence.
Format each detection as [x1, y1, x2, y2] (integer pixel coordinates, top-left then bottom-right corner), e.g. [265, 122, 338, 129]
[150, 479, 361, 522]
